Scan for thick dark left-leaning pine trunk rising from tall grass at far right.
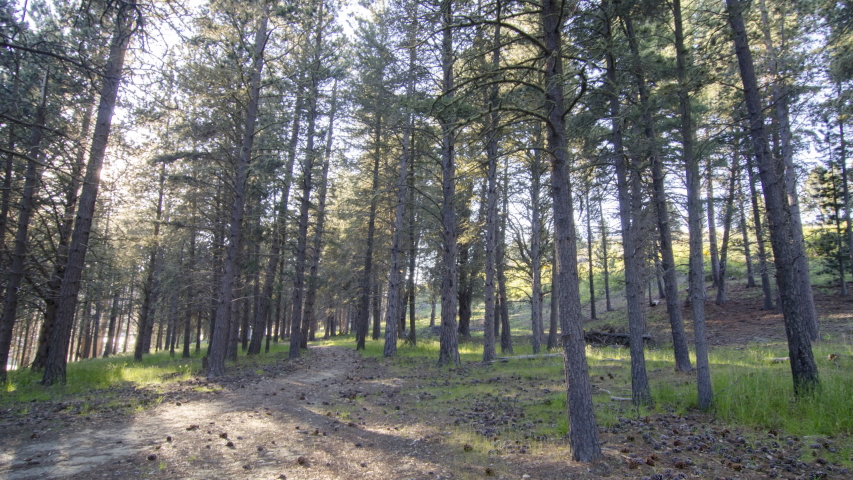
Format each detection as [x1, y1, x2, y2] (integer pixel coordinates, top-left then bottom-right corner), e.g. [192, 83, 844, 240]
[726, 0, 819, 395]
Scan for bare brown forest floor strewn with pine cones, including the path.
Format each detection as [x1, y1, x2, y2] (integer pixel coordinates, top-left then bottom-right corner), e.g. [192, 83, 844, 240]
[0, 282, 853, 480]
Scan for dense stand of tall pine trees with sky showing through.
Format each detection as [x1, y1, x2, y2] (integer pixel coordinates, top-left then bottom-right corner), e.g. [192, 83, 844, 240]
[0, 0, 853, 461]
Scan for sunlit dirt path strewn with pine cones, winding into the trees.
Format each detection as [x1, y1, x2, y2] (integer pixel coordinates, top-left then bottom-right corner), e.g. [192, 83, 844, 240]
[0, 347, 460, 480]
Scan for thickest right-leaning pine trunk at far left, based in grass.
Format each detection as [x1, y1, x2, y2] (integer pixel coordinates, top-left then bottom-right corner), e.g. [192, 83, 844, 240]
[42, 0, 138, 385]
